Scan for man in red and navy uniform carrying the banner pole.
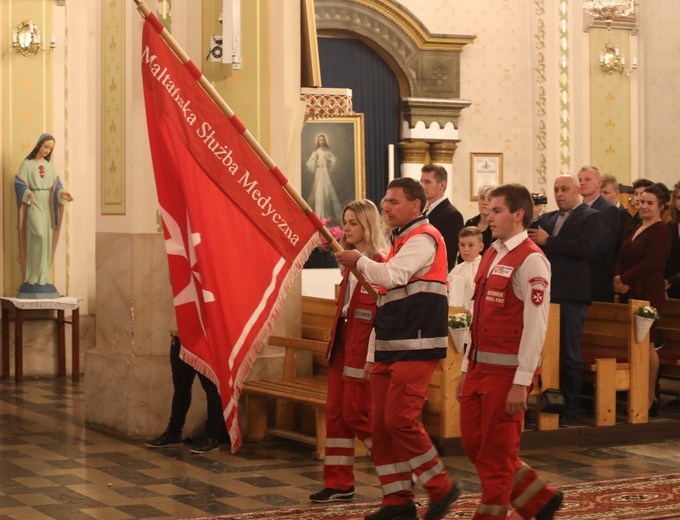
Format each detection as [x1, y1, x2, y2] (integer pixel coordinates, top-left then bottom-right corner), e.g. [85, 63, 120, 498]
[335, 177, 460, 520]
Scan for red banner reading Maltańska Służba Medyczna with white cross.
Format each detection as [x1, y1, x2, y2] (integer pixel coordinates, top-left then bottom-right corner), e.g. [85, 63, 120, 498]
[142, 19, 318, 452]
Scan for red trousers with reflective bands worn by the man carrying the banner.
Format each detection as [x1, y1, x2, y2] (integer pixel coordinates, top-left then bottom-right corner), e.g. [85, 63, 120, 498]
[371, 359, 453, 505]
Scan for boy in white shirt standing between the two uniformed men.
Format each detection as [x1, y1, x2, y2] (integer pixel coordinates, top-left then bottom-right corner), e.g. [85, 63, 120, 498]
[448, 226, 484, 311]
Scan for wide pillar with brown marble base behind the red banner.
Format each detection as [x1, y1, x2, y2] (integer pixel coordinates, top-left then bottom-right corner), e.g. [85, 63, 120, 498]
[84, 1, 211, 438]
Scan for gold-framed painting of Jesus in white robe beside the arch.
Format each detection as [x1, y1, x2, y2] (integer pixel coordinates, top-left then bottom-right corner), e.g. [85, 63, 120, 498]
[300, 114, 366, 226]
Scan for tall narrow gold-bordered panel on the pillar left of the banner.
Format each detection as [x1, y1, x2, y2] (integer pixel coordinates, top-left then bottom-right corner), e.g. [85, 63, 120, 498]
[101, 0, 126, 215]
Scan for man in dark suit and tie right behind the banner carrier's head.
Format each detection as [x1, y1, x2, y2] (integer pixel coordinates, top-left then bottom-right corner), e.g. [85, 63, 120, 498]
[420, 164, 463, 271]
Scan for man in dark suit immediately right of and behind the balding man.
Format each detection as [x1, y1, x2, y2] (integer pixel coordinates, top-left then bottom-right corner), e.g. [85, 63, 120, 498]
[578, 166, 621, 303]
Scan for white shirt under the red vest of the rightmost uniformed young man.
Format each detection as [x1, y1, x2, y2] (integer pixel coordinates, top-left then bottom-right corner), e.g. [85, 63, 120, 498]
[461, 231, 550, 386]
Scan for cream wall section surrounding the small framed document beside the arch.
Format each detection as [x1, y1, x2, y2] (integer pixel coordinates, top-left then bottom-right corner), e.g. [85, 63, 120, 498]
[400, 0, 533, 219]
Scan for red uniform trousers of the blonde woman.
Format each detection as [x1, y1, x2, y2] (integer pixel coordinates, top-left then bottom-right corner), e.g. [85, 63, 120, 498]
[323, 324, 372, 490]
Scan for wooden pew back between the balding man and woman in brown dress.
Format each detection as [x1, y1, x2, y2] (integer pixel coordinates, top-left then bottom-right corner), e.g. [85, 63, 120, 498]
[581, 300, 649, 364]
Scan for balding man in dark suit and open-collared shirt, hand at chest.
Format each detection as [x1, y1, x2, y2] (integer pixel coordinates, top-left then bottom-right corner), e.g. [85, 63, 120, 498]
[529, 175, 604, 426]
